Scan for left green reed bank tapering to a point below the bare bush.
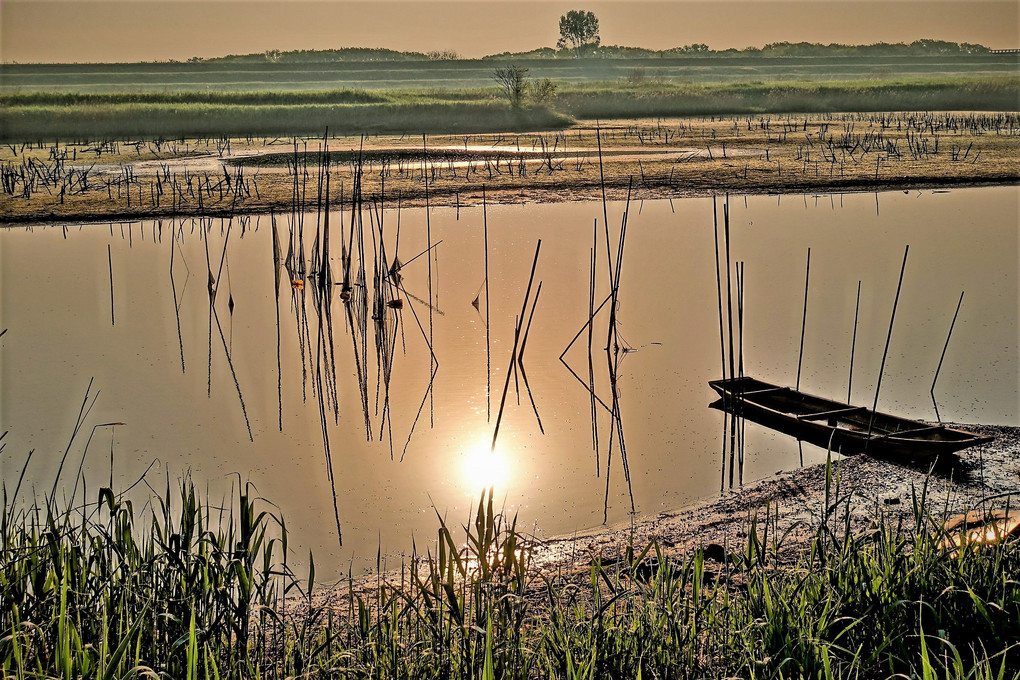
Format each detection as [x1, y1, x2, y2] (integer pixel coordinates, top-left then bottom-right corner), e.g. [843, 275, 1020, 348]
[0, 92, 571, 141]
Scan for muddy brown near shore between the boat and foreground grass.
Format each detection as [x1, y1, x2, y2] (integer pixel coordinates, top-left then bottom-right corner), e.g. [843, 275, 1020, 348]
[306, 423, 1020, 611]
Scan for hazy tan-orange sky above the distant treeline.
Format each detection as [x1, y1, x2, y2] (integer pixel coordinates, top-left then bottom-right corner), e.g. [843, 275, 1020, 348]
[0, 0, 1020, 62]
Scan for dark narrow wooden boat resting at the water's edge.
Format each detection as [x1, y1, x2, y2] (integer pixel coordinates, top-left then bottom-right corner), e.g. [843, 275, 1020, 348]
[709, 376, 992, 461]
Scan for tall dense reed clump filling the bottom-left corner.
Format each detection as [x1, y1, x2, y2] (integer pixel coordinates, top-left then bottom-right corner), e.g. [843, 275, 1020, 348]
[0, 482, 286, 678]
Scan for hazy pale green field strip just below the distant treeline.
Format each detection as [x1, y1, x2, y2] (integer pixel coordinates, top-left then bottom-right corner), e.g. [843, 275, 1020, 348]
[0, 52, 1018, 93]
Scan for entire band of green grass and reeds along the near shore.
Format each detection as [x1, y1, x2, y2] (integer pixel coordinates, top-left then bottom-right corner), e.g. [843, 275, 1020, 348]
[0, 464, 1020, 679]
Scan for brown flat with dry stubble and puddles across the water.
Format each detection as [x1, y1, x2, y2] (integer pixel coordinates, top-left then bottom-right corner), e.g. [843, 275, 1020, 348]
[0, 112, 1020, 222]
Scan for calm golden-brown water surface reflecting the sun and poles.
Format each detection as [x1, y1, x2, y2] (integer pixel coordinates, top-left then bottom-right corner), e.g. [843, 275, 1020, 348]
[0, 187, 1020, 576]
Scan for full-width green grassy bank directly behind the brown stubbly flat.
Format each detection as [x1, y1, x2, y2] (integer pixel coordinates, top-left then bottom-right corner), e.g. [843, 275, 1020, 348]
[0, 76, 1020, 142]
